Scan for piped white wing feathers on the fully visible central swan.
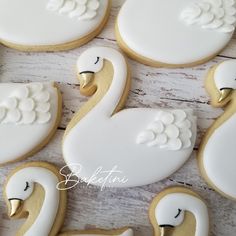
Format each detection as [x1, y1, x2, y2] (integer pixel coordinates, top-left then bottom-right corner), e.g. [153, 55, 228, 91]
[136, 110, 193, 151]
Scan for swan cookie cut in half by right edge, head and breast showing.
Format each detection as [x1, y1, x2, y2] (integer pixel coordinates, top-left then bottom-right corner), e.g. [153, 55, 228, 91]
[198, 60, 236, 200]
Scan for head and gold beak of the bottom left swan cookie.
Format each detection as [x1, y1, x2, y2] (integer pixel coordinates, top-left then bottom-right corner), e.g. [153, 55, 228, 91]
[5, 169, 34, 217]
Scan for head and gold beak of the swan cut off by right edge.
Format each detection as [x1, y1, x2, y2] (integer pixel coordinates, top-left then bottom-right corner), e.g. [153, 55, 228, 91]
[209, 60, 236, 107]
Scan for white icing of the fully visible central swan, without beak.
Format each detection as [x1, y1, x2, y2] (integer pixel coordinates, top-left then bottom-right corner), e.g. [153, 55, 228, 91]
[63, 47, 196, 187]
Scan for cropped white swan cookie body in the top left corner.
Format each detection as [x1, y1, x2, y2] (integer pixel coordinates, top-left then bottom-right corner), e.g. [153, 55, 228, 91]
[0, 0, 110, 51]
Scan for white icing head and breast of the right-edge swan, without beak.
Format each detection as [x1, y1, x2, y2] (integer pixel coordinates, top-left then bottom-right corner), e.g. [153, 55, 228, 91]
[203, 60, 236, 198]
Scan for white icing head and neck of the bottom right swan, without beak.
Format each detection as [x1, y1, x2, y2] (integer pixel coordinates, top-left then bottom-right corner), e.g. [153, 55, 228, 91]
[155, 193, 209, 236]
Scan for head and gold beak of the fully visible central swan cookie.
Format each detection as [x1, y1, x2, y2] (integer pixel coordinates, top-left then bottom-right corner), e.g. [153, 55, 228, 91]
[77, 48, 104, 96]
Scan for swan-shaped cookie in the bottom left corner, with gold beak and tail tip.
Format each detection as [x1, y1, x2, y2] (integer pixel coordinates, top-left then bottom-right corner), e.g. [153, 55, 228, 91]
[4, 162, 133, 236]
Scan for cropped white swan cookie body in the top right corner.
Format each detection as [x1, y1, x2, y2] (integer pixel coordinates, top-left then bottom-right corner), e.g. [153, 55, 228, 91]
[116, 0, 236, 67]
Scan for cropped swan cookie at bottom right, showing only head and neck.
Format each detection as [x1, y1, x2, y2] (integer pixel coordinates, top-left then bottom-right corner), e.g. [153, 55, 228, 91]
[149, 187, 209, 236]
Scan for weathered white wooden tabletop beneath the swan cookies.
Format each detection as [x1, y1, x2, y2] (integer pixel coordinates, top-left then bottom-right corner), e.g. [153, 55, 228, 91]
[0, 0, 236, 236]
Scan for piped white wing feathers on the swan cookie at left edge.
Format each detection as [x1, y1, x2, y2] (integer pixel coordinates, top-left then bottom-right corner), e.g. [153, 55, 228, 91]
[0, 83, 52, 125]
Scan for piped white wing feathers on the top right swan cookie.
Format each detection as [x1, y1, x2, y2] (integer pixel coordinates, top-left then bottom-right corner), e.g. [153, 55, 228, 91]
[181, 0, 236, 33]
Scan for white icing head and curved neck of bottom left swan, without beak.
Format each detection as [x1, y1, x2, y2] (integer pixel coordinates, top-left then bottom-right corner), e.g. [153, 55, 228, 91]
[5, 167, 60, 236]
